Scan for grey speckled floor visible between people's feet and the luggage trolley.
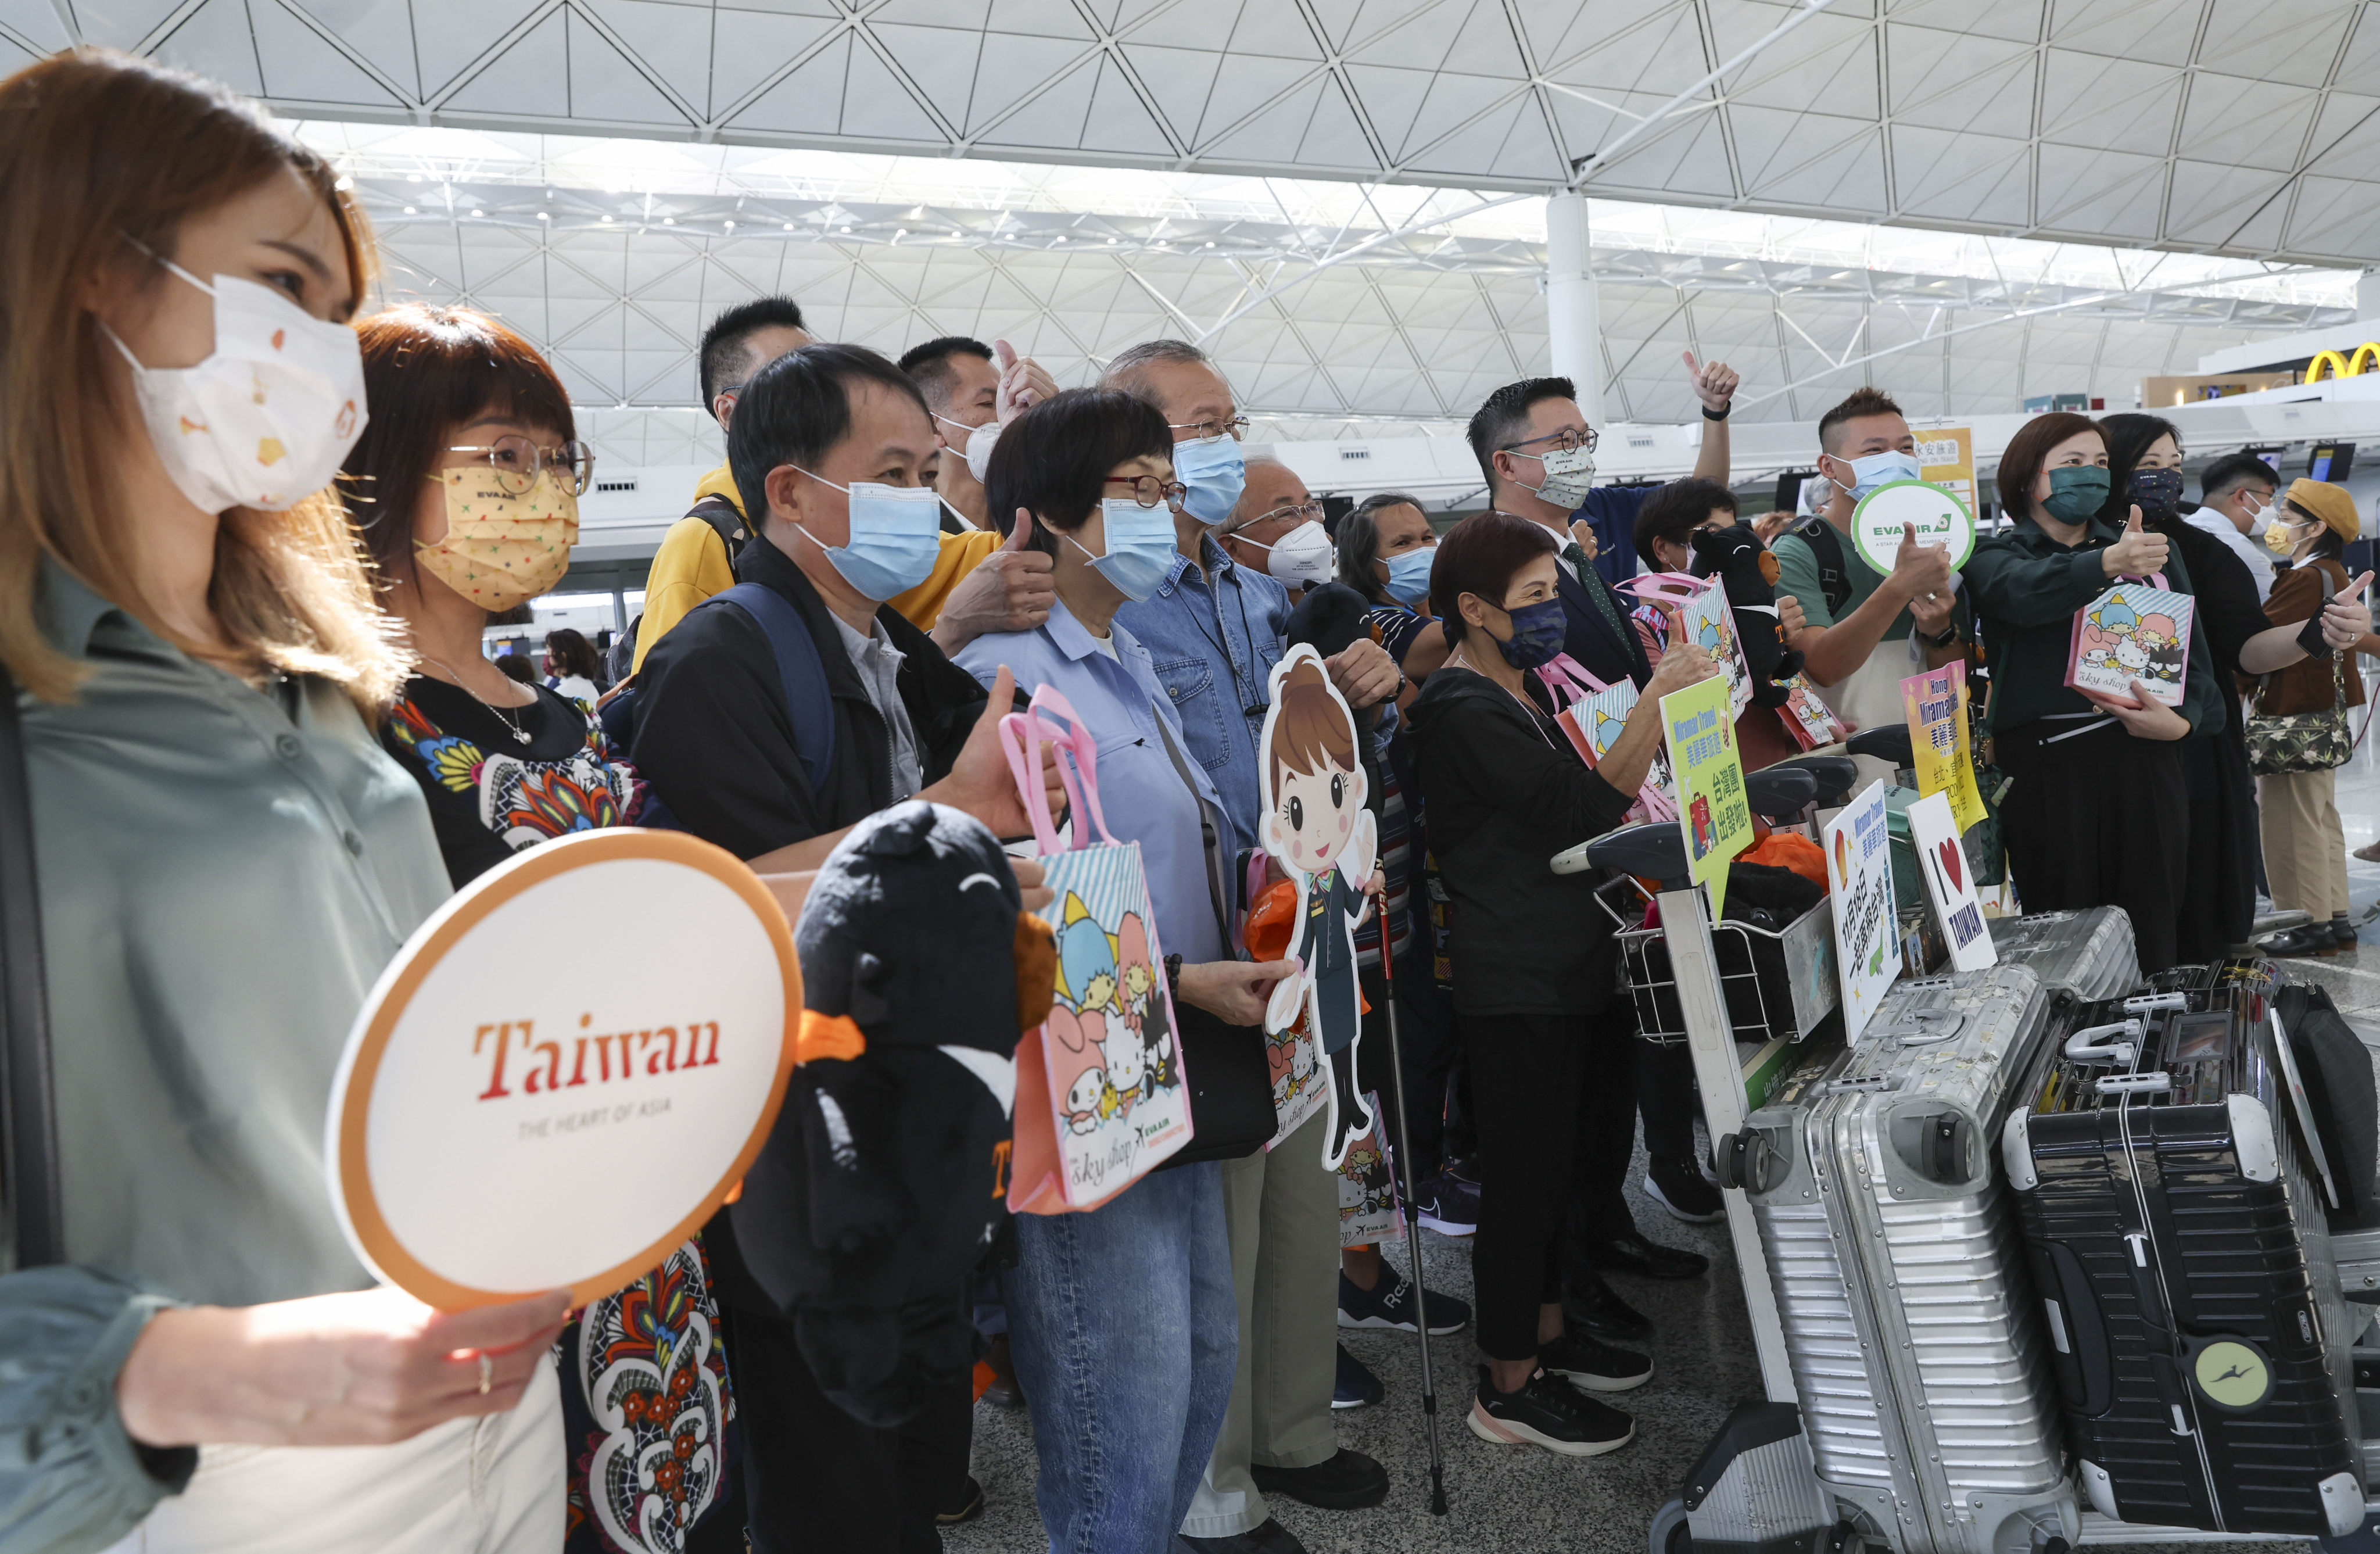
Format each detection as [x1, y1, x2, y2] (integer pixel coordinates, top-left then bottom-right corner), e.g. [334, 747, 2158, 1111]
[945, 745, 2380, 1554]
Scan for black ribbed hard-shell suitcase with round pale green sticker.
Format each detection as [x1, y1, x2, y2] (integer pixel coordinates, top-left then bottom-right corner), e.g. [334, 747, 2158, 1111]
[2002, 961, 2363, 1537]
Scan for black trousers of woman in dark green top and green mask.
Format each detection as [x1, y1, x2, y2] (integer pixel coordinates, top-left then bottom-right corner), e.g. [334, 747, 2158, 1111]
[1997, 719, 2192, 973]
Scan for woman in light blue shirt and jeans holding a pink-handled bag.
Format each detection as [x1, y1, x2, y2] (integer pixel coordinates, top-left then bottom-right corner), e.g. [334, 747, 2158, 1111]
[957, 388, 1290, 1554]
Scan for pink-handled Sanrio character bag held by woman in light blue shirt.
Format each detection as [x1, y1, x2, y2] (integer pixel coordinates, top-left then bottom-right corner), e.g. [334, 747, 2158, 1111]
[999, 685, 1190, 1213]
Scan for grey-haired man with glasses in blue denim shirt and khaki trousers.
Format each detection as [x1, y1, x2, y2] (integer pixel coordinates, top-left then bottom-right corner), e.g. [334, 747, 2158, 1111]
[1099, 341, 1404, 1554]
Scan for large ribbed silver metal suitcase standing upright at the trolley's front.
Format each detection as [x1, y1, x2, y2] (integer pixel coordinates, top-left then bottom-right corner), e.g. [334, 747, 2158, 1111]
[1718, 966, 2080, 1554]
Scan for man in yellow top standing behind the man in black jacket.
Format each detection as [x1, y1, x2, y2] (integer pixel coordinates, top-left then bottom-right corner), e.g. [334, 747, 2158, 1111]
[636, 298, 1057, 669]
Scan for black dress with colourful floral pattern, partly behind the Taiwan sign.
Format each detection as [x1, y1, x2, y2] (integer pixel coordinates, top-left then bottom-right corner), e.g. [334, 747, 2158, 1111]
[381, 676, 743, 1554]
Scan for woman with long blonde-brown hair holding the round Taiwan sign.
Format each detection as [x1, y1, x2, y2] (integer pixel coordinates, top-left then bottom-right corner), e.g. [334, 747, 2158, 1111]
[0, 50, 567, 1554]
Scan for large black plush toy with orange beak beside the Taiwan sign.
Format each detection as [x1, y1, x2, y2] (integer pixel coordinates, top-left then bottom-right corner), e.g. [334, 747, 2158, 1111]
[728, 800, 1057, 1428]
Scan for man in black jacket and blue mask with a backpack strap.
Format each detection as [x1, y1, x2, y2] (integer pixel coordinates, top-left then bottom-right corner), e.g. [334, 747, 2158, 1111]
[633, 345, 1055, 1554]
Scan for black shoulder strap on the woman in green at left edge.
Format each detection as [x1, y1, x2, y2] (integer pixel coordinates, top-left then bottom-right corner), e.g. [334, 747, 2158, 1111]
[0, 667, 67, 1269]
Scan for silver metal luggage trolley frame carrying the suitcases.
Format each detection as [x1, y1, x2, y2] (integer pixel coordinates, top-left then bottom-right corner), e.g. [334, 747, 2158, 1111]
[1554, 794, 2380, 1554]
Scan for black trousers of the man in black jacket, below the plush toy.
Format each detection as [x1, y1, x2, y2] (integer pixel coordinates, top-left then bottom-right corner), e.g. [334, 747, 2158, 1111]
[723, 1306, 973, 1554]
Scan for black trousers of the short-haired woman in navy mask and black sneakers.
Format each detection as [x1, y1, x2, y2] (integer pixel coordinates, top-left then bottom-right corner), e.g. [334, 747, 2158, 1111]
[1464, 1007, 1635, 1361]
